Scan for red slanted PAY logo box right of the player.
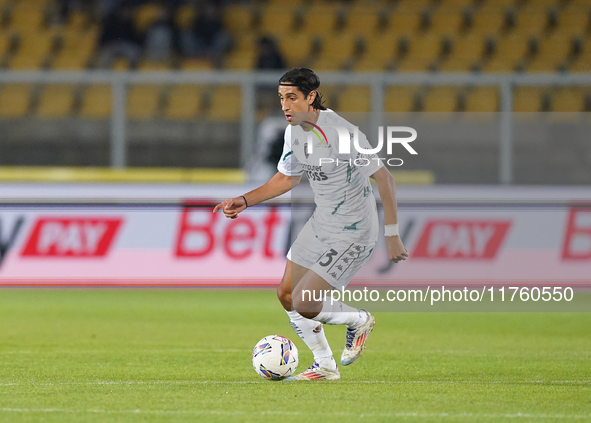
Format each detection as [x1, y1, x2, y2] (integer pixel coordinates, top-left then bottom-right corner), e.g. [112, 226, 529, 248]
[411, 220, 511, 259]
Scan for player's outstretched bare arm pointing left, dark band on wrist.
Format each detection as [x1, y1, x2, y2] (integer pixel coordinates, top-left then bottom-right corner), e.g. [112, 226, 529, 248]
[213, 172, 302, 219]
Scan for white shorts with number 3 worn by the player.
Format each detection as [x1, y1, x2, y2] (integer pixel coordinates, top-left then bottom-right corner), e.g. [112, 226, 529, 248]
[287, 221, 376, 289]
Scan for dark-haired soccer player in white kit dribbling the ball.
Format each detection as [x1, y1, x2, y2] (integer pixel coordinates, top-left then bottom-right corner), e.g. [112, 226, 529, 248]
[213, 68, 408, 380]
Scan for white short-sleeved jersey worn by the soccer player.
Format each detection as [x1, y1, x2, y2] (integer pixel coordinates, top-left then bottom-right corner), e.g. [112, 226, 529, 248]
[277, 110, 383, 245]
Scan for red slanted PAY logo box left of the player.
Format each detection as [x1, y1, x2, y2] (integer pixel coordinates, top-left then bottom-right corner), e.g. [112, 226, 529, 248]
[21, 217, 123, 257]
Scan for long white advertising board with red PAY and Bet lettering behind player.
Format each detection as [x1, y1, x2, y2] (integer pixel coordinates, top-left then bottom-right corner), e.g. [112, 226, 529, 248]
[0, 188, 591, 287]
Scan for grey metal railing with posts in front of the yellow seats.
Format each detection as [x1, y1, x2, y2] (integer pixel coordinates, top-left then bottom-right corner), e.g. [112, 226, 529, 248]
[0, 71, 591, 184]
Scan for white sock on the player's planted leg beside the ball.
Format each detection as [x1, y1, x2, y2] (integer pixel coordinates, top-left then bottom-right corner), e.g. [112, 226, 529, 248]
[285, 310, 337, 370]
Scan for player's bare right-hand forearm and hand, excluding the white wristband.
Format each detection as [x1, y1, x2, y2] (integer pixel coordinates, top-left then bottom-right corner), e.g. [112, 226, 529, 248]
[371, 166, 408, 263]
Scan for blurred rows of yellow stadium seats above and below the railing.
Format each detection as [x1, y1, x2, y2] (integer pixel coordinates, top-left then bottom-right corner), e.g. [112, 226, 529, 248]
[0, 0, 591, 122]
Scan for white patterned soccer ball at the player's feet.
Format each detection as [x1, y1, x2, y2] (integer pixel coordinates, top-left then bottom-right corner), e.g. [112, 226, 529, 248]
[252, 335, 299, 380]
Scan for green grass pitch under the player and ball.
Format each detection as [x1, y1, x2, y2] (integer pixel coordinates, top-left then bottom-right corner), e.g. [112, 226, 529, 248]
[0, 289, 591, 423]
